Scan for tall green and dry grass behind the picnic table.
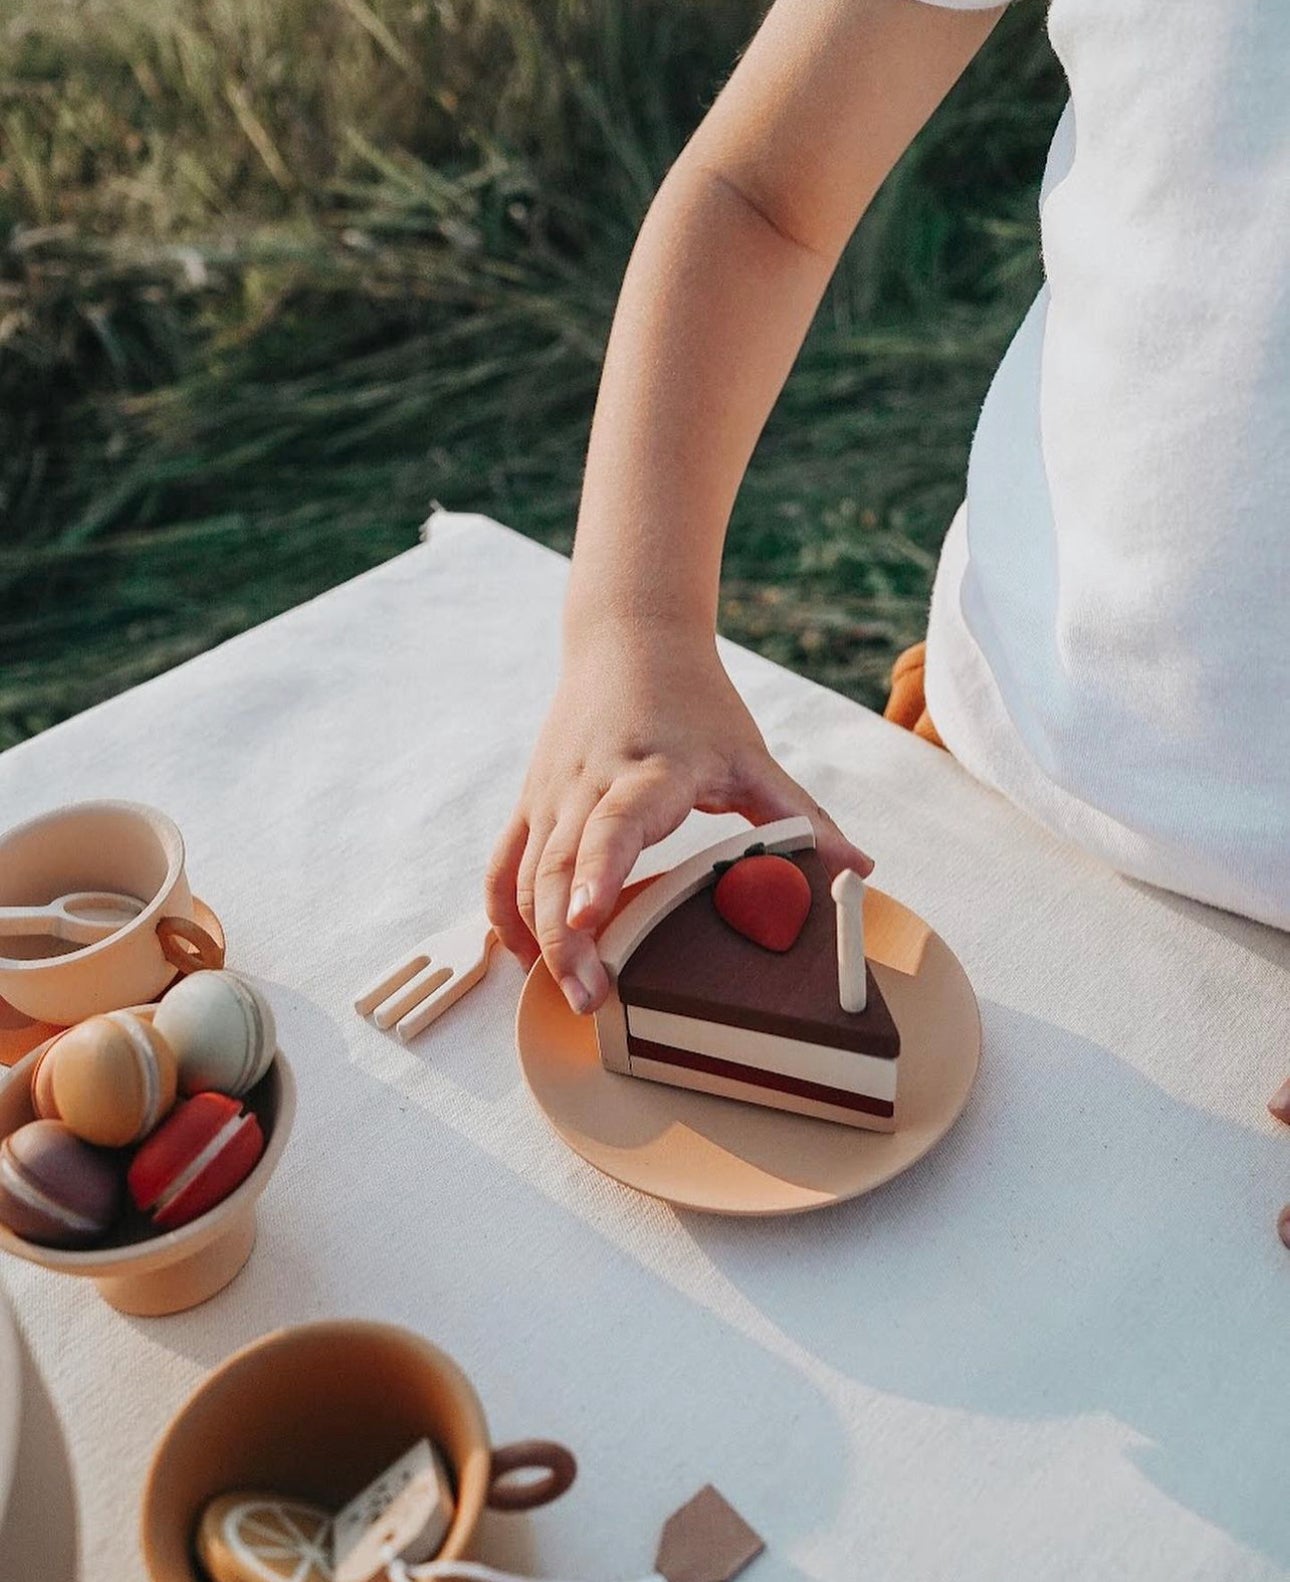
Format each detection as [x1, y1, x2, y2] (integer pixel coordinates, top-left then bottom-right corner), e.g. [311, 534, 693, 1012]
[0, 0, 1062, 745]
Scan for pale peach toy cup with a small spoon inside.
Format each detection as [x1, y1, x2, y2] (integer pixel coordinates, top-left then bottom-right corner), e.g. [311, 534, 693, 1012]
[0, 802, 223, 1027]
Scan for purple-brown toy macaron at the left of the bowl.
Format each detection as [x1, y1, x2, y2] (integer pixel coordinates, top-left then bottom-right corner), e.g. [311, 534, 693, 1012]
[0, 1120, 122, 1247]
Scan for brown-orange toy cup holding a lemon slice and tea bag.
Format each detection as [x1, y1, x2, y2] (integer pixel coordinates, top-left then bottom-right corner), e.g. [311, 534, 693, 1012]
[139, 1319, 578, 1582]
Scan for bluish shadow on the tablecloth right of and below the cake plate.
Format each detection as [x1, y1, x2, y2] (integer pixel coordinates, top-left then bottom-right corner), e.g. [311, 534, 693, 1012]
[682, 1001, 1290, 1565]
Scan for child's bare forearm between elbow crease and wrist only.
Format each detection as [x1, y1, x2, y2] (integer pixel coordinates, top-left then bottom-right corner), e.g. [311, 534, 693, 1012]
[565, 157, 833, 641]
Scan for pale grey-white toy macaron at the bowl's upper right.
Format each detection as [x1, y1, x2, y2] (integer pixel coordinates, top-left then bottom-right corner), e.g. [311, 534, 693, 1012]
[154, 971, 277, 1098]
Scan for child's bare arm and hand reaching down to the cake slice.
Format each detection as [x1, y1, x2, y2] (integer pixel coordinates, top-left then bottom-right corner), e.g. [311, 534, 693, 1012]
[488, 0, 1000, 1009]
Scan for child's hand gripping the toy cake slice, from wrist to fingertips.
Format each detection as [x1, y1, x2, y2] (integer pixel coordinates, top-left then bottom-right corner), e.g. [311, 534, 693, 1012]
[486, 623, 874, 1012]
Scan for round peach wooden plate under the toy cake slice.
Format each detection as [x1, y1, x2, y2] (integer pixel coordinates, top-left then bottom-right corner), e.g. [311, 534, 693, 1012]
[516, 886, 981, 1215]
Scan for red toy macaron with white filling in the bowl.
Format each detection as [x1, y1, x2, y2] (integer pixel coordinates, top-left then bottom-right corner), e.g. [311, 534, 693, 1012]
[125, 1093, 264, 1231]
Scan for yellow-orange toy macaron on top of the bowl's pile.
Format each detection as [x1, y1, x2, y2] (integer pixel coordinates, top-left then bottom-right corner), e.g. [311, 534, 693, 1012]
[43, 1011, 177, 1149]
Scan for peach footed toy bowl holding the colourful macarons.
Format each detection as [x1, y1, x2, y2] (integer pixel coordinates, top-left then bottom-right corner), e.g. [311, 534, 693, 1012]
[0, 1005, 296, 1316]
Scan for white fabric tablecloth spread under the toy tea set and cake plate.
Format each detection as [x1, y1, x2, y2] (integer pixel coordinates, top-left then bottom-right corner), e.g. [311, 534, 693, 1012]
[0, 514, 1290, 1582]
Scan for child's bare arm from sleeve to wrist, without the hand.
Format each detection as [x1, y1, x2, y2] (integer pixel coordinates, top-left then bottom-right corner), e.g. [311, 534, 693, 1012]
[565, 0, 997, 661]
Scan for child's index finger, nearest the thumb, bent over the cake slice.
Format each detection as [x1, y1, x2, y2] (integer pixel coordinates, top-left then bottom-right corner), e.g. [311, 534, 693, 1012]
[568, 770, 695, 932]
